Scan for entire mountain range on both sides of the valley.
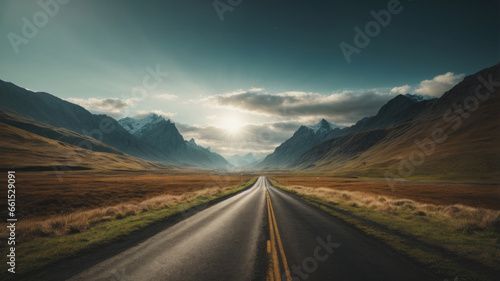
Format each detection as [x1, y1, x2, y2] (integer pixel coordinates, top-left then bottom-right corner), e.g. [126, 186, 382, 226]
[0, 64, 500, 182]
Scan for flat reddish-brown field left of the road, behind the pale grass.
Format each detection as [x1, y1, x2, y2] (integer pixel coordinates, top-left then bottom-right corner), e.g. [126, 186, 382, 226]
[0, 170, 251, 219]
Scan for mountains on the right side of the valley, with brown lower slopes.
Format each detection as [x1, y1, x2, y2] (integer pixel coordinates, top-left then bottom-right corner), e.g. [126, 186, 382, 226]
[260, 64, 500, 182]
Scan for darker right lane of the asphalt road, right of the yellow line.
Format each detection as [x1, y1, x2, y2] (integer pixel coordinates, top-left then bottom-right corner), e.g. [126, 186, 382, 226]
[266, 179, 439, 281]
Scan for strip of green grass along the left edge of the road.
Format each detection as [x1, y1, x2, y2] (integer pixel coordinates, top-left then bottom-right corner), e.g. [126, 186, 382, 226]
[0, 177, 257, 280]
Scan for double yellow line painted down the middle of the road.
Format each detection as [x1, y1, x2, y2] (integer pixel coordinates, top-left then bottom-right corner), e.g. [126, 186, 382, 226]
[266, 187, 292, 281]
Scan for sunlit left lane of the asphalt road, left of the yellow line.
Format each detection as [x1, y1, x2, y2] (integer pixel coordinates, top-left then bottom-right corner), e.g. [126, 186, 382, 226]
[71, 178, 267, 281]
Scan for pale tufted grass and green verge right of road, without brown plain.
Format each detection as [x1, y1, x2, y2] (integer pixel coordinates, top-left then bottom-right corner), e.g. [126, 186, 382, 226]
[271, 179, 500, 280]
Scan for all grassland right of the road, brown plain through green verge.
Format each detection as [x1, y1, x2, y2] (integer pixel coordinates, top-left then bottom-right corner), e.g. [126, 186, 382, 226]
[268, 174, 500, 280]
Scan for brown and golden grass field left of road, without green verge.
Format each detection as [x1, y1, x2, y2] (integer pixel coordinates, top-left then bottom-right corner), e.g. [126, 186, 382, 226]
[0, 170, 252, 241]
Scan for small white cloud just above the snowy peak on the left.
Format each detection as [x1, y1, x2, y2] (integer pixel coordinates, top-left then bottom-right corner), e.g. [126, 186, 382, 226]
[67, 98, 139, 118]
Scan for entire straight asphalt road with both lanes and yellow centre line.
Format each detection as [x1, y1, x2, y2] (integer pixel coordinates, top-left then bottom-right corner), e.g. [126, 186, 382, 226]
[70, 177, 438, 281]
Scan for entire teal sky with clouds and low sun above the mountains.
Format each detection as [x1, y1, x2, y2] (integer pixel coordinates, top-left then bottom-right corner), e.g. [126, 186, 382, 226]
[0, 0, 500, 157]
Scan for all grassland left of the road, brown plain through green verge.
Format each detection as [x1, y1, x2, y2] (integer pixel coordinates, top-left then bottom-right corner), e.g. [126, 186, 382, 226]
[0, 172, 256, 280]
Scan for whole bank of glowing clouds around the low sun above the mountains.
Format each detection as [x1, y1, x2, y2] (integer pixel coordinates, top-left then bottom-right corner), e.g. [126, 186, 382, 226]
[68, 72, 464, 155]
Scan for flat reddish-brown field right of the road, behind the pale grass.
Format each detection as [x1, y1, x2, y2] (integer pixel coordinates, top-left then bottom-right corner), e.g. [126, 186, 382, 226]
[268, 173, 500, 210]
